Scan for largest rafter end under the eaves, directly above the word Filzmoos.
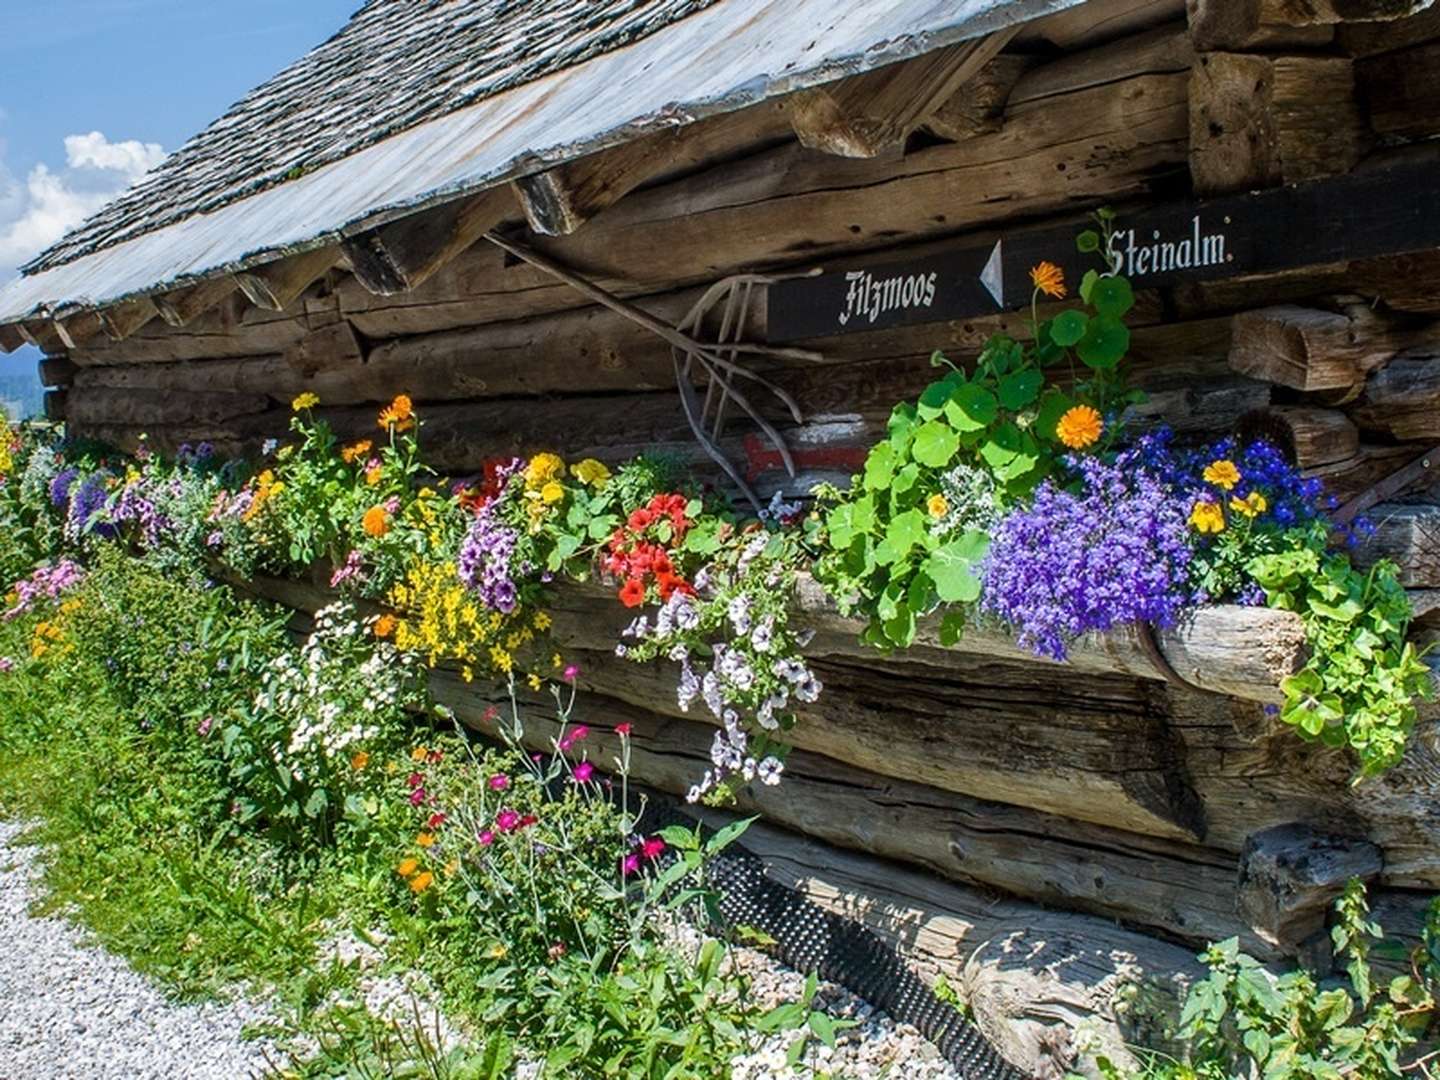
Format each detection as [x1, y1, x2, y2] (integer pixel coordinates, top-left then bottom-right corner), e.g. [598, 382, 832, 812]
[791, 27, 1018, 157]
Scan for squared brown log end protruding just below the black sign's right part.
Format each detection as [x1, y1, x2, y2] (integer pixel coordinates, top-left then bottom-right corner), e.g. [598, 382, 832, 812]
[1230, 304, 1416, 399]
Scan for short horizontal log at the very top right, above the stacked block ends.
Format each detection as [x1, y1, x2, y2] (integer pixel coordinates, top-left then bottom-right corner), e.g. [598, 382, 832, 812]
[1187, 0, 1431, 49]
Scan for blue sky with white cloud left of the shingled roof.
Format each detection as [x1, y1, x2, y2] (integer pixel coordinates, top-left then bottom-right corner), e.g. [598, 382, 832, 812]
[0, 0, 361, 385]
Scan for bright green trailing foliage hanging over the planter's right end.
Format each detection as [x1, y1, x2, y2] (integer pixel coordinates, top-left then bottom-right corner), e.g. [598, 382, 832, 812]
[1247, 527, 1433, 778]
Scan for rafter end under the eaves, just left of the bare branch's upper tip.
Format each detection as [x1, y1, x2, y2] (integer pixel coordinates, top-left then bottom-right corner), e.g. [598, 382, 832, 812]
[344, 187, 516, 297]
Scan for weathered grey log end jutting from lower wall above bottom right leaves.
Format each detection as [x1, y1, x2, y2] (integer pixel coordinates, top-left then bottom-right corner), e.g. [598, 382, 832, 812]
[1236, 825, 1384, 952]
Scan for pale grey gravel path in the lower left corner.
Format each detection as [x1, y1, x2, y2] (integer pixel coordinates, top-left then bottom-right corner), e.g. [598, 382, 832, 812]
[0, 821, 273, 1080]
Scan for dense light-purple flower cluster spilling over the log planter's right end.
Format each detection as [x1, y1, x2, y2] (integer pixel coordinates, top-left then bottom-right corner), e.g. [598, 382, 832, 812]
[981, 451, 1192, 660]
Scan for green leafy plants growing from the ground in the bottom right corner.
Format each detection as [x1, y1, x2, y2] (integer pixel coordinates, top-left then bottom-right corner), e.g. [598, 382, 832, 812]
[1123, 881, 1440, 1080]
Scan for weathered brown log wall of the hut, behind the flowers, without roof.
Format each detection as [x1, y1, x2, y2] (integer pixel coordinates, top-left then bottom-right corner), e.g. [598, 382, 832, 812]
[42, 0, 1440, 1064]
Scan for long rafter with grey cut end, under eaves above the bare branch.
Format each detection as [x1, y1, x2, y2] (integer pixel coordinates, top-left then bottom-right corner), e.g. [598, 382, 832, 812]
[514, 102, 791, 236]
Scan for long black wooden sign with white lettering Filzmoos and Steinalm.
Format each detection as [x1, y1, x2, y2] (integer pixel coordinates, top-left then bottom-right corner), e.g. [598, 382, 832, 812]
[769, 154, 1440, 341]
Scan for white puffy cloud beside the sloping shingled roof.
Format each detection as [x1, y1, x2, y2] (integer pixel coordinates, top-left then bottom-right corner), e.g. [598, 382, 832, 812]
[0, 131, 166, 279]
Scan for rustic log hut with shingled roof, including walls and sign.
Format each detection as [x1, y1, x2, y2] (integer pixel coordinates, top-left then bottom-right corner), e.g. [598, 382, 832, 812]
[8, 0, 1440, 1071]
